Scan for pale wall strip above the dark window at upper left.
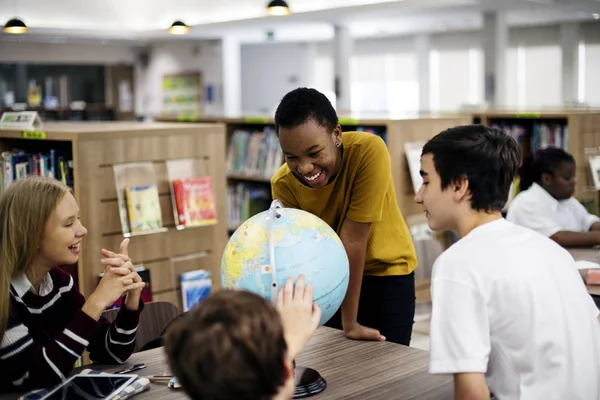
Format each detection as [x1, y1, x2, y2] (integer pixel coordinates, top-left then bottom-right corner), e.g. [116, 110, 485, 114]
[0, 42, 135, 64]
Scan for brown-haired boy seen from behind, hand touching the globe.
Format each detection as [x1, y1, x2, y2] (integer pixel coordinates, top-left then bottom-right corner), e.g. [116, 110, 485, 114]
[165, 275, 321, 400]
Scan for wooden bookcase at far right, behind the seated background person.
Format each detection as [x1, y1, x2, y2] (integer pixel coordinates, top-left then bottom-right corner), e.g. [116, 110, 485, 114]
[471, 109, 600, 215]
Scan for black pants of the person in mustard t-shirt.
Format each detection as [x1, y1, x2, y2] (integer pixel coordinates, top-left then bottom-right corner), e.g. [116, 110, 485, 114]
[325, 273, 415, 346]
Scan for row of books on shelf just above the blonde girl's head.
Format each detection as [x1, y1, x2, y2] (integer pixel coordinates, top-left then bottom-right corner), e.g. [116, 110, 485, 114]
[0, 149, 73, 192]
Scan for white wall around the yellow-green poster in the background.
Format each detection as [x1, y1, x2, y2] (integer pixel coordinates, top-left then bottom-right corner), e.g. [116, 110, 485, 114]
[135, 41, 223, 117]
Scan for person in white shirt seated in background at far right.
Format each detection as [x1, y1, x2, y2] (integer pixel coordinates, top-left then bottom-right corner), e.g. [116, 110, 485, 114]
[506, 148, 600, 247]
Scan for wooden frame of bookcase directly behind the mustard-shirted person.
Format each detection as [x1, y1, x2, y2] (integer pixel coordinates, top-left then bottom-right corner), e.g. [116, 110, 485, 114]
[155, 115, 472, 223]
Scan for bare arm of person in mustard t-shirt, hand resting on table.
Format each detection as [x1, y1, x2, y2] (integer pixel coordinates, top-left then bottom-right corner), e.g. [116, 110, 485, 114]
[340, 218, 385, 340]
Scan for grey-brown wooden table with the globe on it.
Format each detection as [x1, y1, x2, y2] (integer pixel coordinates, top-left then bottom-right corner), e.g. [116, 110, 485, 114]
[0, 327, 454, 400]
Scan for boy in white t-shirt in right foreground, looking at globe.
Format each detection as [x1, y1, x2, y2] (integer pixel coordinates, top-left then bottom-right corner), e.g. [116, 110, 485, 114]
[415, 125, 600, 400]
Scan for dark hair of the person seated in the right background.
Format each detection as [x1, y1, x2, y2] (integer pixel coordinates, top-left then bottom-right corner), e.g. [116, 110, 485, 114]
[519, 147, 575, 190]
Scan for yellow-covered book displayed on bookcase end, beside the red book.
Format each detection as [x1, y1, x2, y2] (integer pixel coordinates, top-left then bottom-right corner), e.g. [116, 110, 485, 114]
[125, 185, 163, 233]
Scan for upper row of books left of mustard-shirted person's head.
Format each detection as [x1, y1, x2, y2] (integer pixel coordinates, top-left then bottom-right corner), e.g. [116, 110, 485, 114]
[227, 127, 283, 179]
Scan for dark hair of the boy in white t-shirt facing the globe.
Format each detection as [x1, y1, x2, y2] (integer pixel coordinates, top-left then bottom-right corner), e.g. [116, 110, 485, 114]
[422, 125, 521, 212]
